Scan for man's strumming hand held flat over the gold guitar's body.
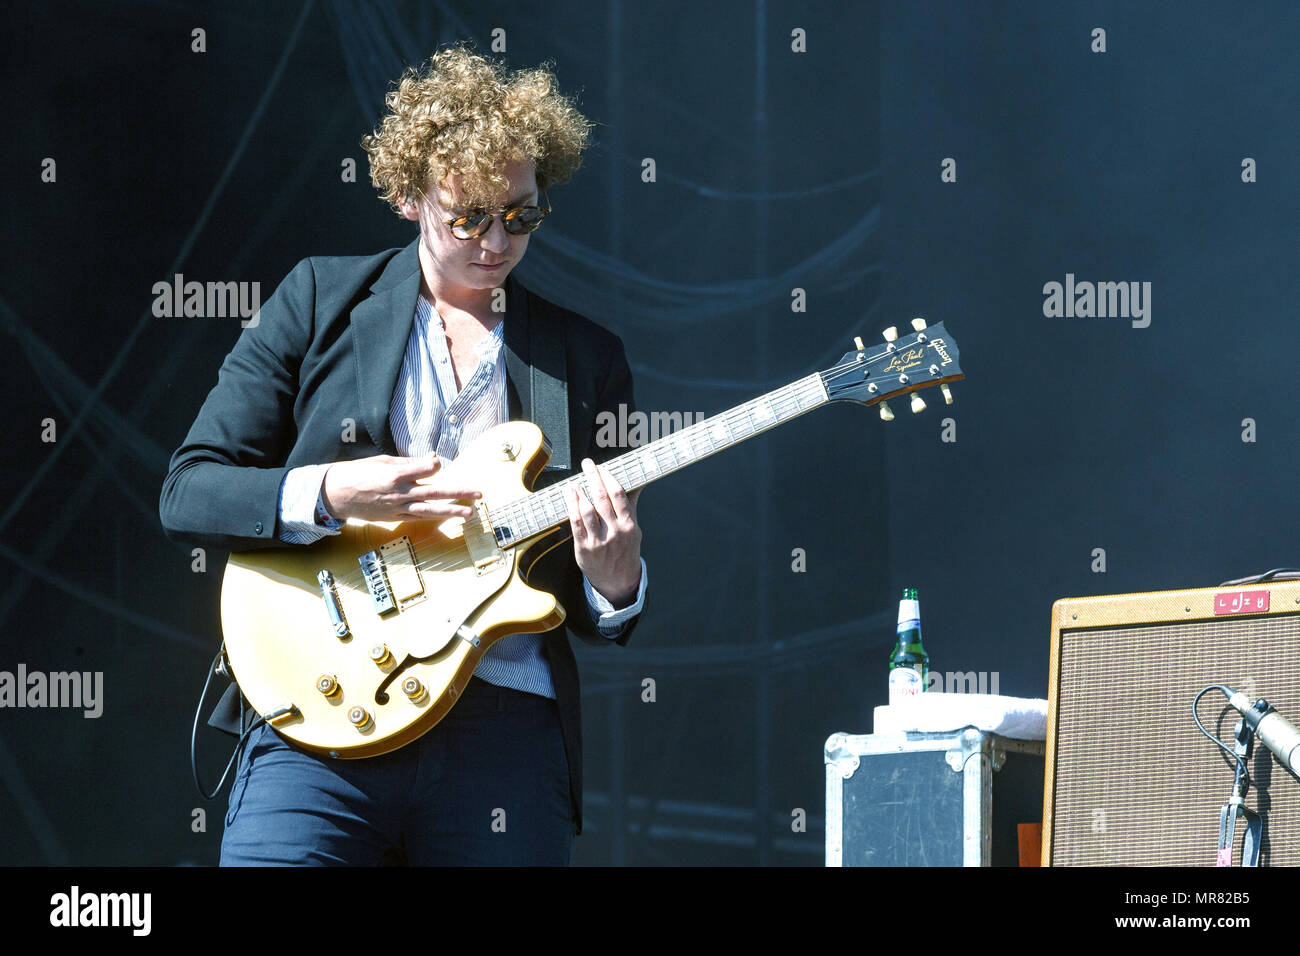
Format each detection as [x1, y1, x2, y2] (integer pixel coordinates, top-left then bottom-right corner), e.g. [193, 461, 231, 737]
[321, 455, 482, 522]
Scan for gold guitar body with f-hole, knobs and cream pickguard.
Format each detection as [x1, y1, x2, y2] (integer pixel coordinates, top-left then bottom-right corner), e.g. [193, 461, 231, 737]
[221, 421, 568, 757]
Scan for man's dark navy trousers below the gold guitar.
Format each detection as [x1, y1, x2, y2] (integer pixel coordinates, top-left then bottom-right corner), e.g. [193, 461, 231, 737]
[221, 678, 576, 866]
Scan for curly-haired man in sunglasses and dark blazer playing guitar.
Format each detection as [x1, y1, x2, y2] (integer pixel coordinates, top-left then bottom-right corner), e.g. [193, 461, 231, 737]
[160, 49, 646, 865]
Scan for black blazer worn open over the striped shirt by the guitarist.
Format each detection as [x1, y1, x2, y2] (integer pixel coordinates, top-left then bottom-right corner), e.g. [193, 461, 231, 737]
[159, 242, 637, 832]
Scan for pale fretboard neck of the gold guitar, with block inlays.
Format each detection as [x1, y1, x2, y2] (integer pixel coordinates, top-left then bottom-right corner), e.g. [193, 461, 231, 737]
[493, 373, 829, 545]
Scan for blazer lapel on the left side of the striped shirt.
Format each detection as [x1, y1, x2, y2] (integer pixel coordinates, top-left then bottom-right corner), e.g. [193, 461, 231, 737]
[352, 238, 420, 455]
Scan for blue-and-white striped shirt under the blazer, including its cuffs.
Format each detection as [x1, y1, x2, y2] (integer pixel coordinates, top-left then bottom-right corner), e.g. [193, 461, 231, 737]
[278, 295, 646, 698]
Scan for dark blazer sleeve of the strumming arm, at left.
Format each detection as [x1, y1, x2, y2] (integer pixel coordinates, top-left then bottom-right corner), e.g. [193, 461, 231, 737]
[159, 259, 316, 551]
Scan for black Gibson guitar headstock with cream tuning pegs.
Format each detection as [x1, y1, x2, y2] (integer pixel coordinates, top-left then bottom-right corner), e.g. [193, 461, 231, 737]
[819, 319, 966, 421]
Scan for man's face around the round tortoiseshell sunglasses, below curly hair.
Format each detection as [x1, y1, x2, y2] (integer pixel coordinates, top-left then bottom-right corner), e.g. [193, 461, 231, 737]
[402, 160, 537, 291]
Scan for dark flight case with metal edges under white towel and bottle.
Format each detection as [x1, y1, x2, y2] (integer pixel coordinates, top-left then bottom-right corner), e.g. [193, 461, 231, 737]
[824, 727, 1043, 866]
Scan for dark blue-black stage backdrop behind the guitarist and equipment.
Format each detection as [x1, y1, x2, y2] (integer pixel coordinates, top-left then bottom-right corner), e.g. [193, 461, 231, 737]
[0, 0, 1300, 865]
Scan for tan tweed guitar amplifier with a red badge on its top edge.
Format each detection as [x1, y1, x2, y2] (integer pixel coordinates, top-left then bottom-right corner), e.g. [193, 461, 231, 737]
[1043, 581, 1300, 866]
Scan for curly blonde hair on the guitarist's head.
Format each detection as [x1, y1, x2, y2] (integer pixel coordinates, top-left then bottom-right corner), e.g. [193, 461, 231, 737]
[361, 47, 592, 212]
